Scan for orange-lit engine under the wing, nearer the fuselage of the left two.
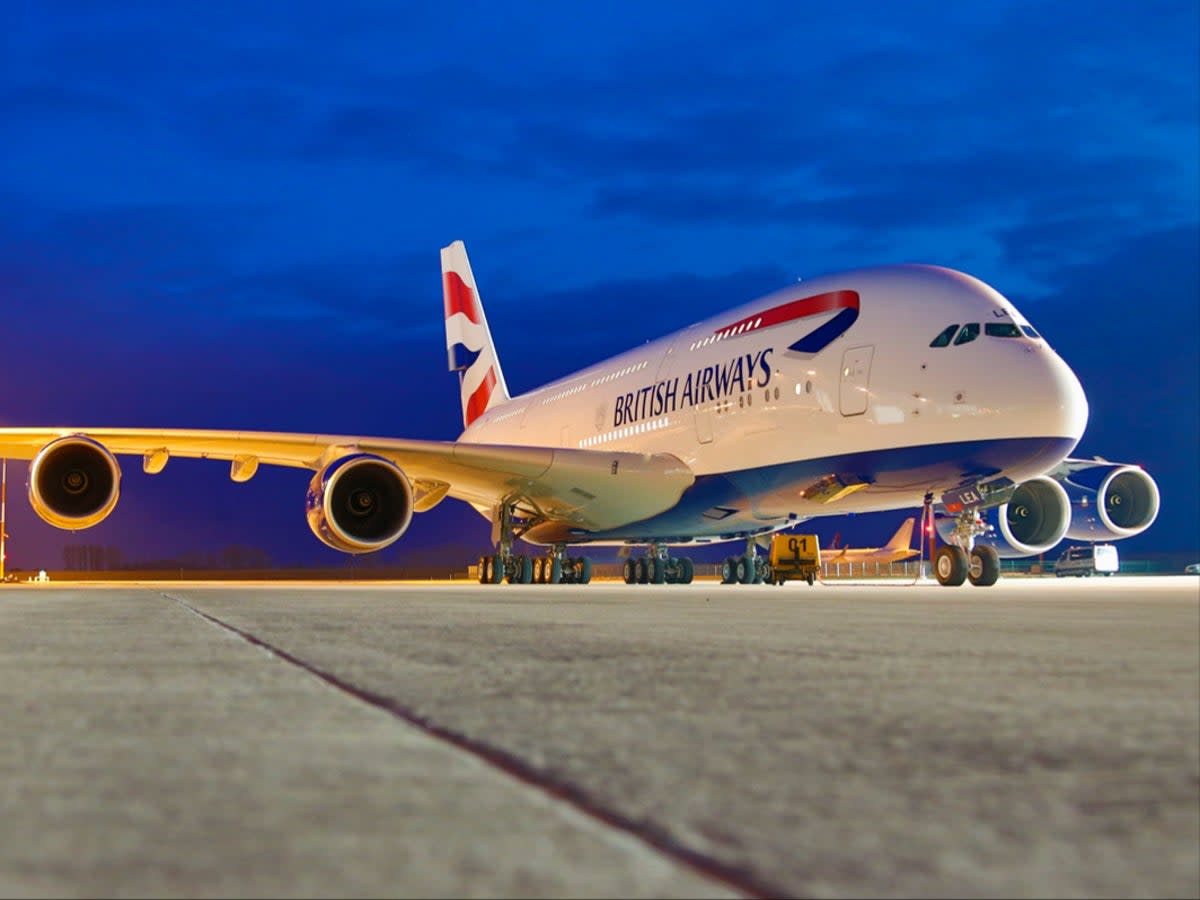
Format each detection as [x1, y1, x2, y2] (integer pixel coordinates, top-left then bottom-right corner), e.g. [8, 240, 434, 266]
[305, 454, 413, 553]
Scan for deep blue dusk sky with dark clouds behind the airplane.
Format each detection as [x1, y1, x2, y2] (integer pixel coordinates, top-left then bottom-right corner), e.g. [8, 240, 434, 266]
[0, 0, 1200, 568]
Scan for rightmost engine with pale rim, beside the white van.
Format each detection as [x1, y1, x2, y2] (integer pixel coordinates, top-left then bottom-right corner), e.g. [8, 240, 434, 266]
[1062, 462, 1159, 541]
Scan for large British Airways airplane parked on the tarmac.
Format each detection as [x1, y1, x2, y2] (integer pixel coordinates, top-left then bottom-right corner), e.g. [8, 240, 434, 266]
[0, 241, 1159, 587]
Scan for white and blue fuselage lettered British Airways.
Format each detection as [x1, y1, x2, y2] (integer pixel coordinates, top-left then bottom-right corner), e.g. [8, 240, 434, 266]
[461, 265, 1087, 540]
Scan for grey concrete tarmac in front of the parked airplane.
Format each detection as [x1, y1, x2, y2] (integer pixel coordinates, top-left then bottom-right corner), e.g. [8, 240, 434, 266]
[0, 576, 1200, 898]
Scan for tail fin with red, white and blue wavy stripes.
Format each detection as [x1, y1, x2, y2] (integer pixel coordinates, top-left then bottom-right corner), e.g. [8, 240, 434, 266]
[442, 241, 509, 427]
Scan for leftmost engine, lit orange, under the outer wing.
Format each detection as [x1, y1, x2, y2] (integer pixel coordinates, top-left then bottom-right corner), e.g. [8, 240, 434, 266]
[29, 434, 121, 530]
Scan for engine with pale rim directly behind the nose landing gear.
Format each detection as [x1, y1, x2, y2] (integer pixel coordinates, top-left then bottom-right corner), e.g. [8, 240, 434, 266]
[936, 475, 1070, 557]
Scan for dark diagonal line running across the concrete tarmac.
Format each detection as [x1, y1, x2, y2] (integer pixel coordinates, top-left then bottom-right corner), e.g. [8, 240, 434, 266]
[166, 592, 793, 899]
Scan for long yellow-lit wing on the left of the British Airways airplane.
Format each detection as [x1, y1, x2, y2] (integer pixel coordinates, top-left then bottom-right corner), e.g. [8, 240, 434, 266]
[0, 428, 695, 530]
